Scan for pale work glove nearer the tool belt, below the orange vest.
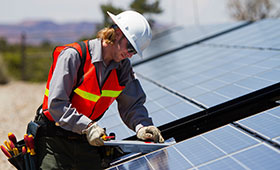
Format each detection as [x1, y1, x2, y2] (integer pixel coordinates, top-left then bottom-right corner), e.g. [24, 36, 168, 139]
[82, 122, 105, 146]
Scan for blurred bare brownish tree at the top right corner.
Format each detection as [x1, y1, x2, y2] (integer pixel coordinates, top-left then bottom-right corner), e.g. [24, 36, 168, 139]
[227, 0, 280, 21]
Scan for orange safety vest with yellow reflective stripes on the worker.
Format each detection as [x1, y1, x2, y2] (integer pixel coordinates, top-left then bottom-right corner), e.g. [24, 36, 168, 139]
[42, 40, 125, 121]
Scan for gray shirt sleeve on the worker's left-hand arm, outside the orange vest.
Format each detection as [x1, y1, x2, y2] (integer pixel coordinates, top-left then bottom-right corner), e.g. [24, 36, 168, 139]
[48, 48, 91, 134]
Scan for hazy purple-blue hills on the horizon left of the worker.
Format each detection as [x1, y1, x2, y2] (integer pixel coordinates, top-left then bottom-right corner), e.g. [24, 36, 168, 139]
[0, 20, 98, 45]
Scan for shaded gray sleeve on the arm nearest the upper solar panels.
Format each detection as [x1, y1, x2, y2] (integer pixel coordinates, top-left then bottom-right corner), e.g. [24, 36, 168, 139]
[117, 60, 153, 131]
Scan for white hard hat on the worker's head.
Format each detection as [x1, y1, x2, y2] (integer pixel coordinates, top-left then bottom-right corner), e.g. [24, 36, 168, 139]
[107, 11, 152, 57]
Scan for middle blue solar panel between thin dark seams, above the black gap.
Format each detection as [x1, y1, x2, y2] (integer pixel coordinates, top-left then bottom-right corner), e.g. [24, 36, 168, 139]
[135, 45, 280, 107]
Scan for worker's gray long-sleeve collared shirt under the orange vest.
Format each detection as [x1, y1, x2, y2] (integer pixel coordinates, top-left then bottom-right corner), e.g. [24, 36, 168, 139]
[48, 39, 152, 134]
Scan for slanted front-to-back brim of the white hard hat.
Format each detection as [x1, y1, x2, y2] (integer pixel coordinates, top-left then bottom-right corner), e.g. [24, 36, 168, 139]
[107, 11, 142, 58]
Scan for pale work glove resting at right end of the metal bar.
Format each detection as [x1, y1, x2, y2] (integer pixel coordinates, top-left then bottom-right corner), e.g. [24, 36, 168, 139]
[137, 126, 164, 143]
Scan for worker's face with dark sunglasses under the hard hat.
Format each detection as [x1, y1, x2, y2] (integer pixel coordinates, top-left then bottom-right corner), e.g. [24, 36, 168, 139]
[113, 30, 136, 62]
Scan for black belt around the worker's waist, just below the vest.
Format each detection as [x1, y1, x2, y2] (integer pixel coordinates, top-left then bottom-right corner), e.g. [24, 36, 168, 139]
[34, 107, 87, 142]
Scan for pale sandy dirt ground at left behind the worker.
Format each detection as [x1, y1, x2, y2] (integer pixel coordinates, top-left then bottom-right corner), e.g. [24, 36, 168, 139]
[0, 82, 45, 170]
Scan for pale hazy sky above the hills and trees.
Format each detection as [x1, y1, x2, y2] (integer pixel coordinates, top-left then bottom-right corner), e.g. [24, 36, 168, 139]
[0, 0, 233, 25]
